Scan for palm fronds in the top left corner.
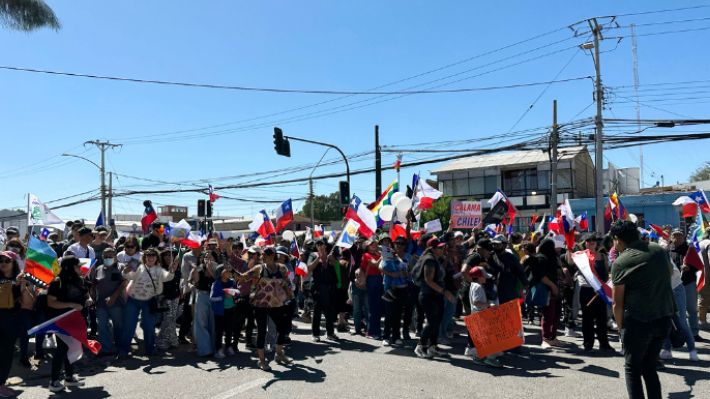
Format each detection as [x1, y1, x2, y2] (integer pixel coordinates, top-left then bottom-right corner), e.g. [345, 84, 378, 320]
[0, 0, 61, 32]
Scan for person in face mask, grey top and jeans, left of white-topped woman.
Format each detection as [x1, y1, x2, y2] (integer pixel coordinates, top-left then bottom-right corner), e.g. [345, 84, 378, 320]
[89, 247, 127, 356]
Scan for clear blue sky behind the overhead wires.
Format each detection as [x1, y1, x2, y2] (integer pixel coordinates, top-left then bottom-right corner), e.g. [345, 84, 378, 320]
[0, 0, 710, 219]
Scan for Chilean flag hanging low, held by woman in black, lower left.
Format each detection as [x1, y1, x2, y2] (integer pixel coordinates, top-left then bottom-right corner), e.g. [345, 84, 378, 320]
[27, 309, 101, 363]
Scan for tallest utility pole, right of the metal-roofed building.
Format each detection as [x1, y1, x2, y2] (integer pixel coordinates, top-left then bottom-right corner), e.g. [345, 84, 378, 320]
[589, 18, 604, 234]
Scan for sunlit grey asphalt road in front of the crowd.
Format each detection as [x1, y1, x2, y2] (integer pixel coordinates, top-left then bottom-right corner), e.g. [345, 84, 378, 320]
[6, 322, 710, 399]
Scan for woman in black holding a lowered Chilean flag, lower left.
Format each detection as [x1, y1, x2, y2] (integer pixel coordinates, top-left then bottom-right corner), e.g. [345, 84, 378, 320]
[47, 256, 90, 392]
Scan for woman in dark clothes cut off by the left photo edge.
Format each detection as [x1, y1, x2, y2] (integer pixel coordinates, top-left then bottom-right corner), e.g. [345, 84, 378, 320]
[0, 251, 21, 398]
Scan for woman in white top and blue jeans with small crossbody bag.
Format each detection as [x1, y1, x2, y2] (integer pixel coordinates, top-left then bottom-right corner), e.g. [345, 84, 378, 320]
[118, 248, 177, 356]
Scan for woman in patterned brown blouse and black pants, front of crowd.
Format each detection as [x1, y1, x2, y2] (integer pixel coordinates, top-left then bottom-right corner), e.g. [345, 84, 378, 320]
[237, 247, 293, 371]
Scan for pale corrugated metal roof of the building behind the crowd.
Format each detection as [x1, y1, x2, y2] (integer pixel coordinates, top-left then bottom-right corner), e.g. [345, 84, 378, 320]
[431, 146, 587, 174]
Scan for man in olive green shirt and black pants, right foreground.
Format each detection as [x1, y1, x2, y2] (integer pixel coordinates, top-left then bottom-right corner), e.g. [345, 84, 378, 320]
[609, 221, 675, 399]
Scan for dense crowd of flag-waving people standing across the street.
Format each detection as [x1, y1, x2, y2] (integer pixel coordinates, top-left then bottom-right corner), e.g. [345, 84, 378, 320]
[0, 217, 710, 397]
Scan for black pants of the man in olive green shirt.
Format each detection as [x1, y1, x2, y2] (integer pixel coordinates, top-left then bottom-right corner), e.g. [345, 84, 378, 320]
[621, 317, 671, 399]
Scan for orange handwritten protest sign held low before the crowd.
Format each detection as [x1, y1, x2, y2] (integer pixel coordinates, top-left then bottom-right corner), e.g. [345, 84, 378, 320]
[464, 300, 525, 358]
